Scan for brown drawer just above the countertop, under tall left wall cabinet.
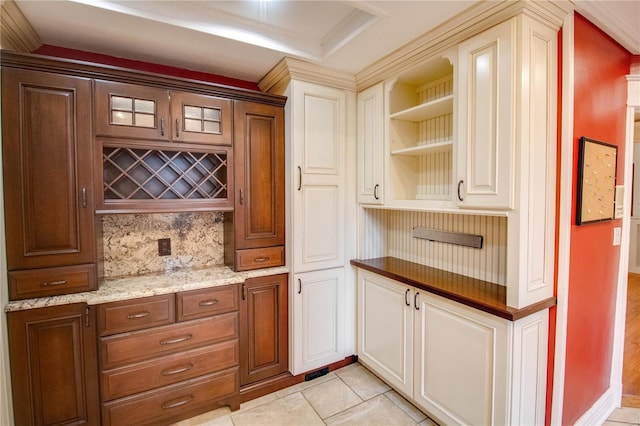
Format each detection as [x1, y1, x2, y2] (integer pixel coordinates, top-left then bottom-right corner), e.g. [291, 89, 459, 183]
[8, 264, 98, 300]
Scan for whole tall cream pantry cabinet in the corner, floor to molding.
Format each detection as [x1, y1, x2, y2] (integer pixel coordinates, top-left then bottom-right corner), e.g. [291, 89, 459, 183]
[263, 59, 356, 375]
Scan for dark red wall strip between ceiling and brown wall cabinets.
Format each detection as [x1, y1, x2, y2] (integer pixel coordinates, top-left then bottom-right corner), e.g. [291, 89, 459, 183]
[33, 44, 260, 90]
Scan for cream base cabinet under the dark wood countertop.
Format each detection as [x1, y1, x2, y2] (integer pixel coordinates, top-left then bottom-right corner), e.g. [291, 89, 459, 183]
[357, 269, 548, 425]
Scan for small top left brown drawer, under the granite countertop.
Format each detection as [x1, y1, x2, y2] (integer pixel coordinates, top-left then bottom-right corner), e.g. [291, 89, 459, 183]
[98, 294, 175, 336]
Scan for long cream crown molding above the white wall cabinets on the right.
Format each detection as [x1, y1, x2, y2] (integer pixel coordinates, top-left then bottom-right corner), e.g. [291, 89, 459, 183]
[356, 0, 572, 90]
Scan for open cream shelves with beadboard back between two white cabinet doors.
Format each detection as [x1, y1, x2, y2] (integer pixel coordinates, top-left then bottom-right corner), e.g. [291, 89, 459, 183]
[386, 58, 455, 205]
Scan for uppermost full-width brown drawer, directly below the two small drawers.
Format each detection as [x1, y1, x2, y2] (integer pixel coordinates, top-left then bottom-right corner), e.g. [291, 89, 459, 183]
[100, 312, 239, 369]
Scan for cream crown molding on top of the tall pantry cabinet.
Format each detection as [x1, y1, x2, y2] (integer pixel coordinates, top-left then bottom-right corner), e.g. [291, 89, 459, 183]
[258, 58, 356, 95]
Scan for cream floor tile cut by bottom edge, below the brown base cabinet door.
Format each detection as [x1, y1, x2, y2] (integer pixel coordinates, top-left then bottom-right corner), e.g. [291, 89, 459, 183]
[231, 392, 324, 426]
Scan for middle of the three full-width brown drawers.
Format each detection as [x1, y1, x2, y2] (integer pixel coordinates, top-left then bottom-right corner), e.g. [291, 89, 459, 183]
[101, 339, 239, 401]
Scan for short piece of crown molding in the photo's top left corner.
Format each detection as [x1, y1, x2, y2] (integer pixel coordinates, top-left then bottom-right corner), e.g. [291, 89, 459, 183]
[0, 0, 42, 53]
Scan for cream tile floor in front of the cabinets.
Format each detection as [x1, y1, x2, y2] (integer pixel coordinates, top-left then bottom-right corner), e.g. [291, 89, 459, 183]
[174, 364, 640, 426]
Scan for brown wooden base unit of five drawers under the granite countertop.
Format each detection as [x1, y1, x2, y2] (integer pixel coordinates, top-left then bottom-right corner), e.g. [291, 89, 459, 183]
[98, 284, 240, 425]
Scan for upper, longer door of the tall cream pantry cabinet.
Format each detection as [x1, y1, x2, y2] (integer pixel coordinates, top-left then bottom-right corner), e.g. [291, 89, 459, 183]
[291, 81, 346, 272]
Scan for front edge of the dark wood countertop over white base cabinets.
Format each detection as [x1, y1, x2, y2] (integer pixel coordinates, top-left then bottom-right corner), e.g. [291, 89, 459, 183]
[350, 259, 556, 321]
